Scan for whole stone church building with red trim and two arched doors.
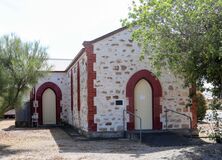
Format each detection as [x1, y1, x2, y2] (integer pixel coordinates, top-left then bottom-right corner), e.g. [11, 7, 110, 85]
[31, 28, 197, 136]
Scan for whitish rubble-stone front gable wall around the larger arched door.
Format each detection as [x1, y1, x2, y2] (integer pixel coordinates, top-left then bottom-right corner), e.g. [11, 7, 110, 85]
[94, 30, 191, 132]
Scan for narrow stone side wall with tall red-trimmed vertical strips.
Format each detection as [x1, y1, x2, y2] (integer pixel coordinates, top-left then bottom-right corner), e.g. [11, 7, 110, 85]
[67, 53, 88, 131]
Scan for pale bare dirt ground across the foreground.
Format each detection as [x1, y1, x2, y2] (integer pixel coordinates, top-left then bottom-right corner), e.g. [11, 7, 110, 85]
[0, 120, 222, 160]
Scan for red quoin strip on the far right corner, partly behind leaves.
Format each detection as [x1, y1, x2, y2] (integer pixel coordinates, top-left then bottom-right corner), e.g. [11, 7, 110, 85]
[190, 85, 197, 129]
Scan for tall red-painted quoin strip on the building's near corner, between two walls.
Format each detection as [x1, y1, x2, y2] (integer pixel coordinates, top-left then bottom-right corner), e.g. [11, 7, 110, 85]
[83, 42, 97, 132]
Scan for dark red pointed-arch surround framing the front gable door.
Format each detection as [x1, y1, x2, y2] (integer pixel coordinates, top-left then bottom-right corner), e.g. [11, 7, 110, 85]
[126, 70, 162, 130]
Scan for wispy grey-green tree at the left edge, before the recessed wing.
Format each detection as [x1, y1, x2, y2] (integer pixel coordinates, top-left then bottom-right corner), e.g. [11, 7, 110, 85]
[0, 34, 50, 114]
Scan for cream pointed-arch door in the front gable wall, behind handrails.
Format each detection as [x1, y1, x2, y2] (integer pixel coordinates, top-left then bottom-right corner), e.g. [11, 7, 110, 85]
[134, 79, 153, 129]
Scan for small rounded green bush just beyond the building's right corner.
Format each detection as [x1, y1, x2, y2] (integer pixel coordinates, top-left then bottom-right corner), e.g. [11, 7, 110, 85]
[196, 92, 207, 121]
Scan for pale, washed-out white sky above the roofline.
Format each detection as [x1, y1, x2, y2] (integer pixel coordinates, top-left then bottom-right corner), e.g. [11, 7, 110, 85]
[0, 0, 131, 69]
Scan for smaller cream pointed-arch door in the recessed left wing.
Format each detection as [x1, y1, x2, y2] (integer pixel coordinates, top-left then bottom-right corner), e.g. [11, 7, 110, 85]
[42, 88, 56, 124]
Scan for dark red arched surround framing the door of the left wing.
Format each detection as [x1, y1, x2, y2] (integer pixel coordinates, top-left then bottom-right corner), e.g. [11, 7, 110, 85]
[36, 82, 62, 125]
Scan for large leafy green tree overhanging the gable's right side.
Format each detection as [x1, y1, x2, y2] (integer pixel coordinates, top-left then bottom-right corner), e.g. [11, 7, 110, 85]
[123, 0, 222, 97]
